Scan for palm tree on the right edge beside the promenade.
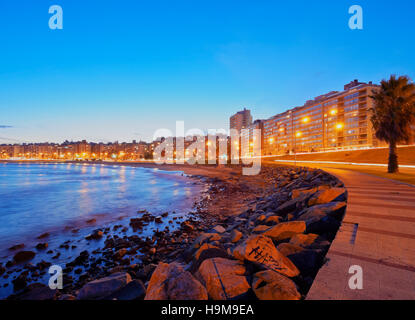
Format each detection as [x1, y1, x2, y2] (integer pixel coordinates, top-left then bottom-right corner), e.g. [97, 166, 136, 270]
[370, 75, 415, 173]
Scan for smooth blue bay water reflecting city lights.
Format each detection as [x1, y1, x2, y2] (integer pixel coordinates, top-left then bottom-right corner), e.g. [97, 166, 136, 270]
[0, 163, 201, 295]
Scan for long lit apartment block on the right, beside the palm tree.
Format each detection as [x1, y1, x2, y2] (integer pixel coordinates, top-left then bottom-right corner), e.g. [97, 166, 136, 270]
[263, 80, 384, 155]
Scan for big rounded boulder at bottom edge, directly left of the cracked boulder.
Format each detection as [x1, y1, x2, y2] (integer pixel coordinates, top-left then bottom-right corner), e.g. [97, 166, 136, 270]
[145, 262, 208, 300]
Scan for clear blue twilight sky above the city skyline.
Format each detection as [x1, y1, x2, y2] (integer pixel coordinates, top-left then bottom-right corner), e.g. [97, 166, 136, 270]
[0, 0, 415, 143]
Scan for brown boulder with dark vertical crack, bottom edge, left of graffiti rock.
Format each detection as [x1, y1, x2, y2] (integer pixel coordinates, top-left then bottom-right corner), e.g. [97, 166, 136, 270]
[199, 258, 251, 300]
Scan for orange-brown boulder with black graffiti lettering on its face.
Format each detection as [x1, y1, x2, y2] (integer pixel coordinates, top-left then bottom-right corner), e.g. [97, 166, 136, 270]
[233, 235, 300, 277]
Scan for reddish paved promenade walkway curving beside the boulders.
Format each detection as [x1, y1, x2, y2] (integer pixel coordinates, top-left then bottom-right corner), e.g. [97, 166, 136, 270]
[307, 167, 415, 300]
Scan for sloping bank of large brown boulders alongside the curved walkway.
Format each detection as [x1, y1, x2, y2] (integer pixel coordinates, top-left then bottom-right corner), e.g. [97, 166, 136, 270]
[140, 168, 347, 300]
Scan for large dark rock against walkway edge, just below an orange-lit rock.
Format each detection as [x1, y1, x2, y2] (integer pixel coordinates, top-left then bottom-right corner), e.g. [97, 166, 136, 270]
[297, 202, 346, 233]
